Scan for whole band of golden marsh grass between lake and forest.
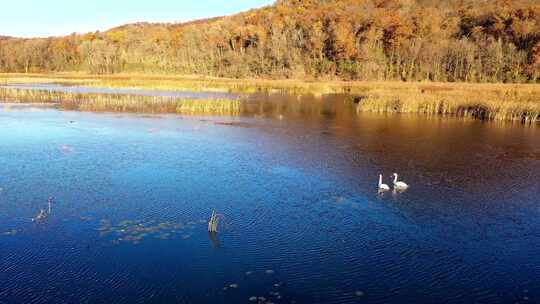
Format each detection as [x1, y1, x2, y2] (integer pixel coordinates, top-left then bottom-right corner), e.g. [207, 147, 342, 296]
[0, 73, 540, 125]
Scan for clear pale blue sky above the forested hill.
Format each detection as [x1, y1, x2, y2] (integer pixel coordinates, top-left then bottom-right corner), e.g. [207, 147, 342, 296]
[0, 0, 274, 37]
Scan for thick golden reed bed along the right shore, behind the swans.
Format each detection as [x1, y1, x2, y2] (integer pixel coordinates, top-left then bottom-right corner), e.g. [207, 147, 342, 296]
[357, 86, 540, 124]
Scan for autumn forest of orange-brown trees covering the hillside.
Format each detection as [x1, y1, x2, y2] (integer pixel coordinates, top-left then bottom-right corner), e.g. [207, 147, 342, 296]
[0, 0, 540, 83]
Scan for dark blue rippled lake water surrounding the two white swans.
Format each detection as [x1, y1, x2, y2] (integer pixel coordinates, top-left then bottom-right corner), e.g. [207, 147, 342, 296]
[0, 105, 540, 303]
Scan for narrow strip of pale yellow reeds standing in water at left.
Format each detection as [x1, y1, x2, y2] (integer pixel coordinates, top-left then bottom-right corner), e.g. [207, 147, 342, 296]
[0, 88, 241, 115]
